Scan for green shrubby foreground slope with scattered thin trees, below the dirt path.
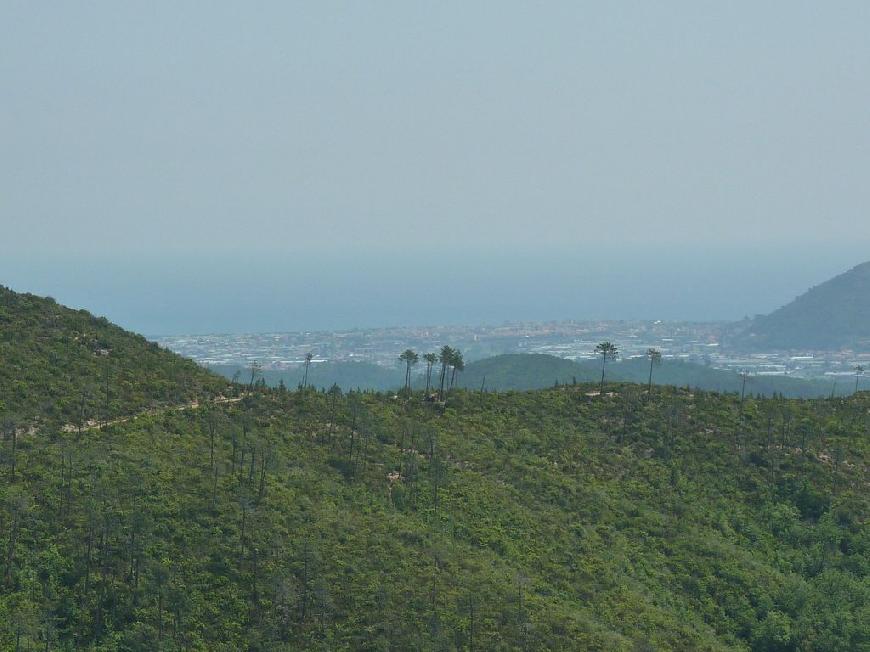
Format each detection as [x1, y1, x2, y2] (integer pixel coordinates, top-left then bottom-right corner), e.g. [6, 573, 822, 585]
[0, 386, 870, 651]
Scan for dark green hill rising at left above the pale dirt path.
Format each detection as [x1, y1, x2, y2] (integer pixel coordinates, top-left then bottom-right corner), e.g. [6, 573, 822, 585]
[0, 286, 226, 423]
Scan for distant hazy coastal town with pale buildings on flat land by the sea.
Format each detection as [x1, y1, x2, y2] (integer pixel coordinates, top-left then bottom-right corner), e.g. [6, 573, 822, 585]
[154, 320, 870, 379]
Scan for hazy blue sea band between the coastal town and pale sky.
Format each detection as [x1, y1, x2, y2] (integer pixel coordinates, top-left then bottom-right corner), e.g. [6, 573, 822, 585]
[0, 243, 868, 335]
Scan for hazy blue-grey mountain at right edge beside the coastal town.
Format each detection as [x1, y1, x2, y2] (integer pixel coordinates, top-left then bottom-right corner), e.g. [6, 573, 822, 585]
[726, 262, 870, 350]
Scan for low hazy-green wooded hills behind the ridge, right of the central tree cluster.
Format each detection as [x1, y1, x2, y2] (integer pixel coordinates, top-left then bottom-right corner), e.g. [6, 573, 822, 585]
[459, 353, 848, 398]
